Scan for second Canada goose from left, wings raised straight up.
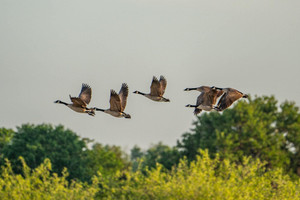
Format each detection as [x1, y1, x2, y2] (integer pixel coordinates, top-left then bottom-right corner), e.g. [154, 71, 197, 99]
[94, 83, 131, 119]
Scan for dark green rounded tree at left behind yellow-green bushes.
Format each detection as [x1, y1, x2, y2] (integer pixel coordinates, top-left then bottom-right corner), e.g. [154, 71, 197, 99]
[3, 124, 90, 180]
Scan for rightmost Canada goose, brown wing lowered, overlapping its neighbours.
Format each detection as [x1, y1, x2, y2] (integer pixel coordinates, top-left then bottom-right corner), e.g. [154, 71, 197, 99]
[214, 88, 248, 111]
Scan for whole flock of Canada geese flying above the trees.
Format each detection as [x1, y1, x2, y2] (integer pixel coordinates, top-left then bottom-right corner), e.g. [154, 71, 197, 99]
[54, 76, 248, 119]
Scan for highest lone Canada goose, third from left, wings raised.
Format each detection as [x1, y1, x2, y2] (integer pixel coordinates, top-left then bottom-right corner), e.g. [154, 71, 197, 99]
[133, 76, 170, 102]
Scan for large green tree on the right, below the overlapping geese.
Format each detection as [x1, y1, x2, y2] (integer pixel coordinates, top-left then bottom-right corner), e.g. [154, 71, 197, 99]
[177, 96, 300, 171]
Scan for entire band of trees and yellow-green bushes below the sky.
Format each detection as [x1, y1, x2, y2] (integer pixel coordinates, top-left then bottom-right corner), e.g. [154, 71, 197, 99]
[0, 96, 300, 199]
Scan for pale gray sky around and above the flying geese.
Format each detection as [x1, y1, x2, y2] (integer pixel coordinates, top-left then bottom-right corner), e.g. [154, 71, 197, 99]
[0, 0, 300, 149]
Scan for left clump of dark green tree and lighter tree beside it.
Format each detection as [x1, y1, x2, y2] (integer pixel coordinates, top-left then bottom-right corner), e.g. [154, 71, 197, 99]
[0, 124, 130, 182]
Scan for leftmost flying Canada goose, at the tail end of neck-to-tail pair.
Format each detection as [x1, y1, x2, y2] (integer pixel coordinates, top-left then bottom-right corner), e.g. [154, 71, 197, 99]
[54, 83, 95, 116]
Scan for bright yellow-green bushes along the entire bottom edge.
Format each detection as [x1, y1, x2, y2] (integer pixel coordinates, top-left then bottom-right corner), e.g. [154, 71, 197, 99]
[0, 151, 300, 200]
